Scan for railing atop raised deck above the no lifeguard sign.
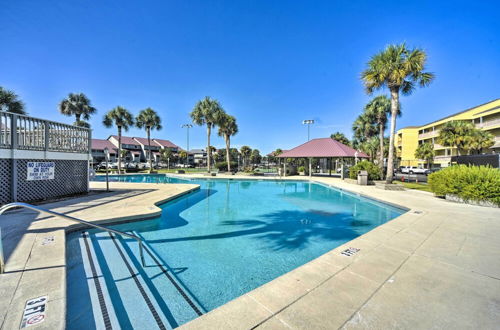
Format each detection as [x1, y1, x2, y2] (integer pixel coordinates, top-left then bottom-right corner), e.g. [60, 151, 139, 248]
[0, 111, 90, 153]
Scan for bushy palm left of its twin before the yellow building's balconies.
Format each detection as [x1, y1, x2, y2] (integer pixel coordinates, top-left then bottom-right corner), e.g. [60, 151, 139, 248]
[437, 120, 475, 156]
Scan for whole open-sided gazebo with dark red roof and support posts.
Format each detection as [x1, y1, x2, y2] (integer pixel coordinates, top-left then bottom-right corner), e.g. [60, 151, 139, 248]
[277, 138, 369, 179]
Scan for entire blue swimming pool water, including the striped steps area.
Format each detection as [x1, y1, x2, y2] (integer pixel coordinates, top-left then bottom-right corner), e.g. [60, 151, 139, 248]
[67, 175, 405, 329]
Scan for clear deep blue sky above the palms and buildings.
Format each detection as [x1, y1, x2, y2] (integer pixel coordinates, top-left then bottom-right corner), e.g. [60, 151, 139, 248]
[0, 0, 500, 153]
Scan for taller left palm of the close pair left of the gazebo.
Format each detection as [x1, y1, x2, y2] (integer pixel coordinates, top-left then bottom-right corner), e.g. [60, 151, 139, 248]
[190, 96, 225, 173]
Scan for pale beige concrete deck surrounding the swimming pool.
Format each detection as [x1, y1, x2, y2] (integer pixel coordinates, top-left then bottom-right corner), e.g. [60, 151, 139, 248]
[0, 175, 500, 329]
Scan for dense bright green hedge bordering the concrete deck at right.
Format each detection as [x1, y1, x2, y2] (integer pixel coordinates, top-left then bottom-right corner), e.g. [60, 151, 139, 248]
[428, 165, 500, 205]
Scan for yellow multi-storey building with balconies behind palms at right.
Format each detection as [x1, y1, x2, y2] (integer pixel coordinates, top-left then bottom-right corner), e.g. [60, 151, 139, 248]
[396, 99, 500, 166]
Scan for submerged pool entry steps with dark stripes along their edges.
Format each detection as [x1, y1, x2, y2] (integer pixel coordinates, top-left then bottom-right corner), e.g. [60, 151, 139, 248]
[80, 232, 204, 329]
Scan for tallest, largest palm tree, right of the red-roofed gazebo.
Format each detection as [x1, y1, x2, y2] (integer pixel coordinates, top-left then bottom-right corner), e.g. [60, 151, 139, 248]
[361, 43, 434, 183]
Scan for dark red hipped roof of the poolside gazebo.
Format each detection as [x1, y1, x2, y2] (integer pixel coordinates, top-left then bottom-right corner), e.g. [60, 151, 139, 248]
[277, 138, 368, 158]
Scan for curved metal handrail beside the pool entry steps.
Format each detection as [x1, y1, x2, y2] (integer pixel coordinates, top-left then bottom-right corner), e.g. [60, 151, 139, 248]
[0, 202, 145, 274]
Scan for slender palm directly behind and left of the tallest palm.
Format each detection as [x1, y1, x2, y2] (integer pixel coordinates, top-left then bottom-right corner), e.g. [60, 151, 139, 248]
[365, 95, 394, 169]
